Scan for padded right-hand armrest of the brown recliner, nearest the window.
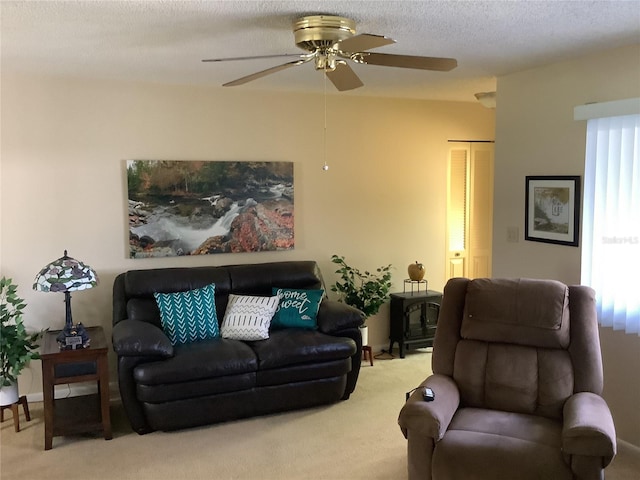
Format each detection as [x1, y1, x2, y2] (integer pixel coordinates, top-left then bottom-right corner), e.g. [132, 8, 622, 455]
[562, 392, 616, 466]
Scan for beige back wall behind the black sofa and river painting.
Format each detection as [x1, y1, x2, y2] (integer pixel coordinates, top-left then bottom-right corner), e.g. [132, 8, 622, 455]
[0, 75, 495, 393]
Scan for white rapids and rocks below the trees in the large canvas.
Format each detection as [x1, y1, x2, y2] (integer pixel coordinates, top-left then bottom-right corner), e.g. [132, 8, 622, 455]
[129, 183, 294, 258]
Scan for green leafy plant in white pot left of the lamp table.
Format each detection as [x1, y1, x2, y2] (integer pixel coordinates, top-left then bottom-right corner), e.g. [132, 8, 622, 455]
[0, 277, 43, 405]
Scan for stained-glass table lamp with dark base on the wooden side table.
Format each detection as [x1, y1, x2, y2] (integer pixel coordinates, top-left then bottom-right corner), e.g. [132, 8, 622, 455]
[33, 250, 98, 343]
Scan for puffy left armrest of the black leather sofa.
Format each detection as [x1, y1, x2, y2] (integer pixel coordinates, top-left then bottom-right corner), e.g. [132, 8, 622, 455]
[112, 320, 173, 358]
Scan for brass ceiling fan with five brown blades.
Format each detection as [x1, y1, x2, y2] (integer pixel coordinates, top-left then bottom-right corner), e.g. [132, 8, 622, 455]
[202, 15, 458, 91]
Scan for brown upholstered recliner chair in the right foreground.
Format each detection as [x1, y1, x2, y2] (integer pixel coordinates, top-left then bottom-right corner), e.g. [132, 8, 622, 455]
[398, 278, 616, 480]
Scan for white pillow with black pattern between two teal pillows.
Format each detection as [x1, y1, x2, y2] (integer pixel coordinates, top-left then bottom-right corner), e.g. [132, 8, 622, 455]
[220, 294, 279, 341]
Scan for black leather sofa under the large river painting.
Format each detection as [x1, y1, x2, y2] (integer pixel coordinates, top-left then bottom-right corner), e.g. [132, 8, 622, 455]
[112, 261, 364, 434]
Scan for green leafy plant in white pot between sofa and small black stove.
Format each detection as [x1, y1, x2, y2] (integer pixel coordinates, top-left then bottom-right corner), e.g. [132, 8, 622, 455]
[331, 255, 391, 345]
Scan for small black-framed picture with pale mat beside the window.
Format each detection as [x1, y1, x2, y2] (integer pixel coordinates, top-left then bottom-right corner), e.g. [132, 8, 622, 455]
[524, 175, 580, 247]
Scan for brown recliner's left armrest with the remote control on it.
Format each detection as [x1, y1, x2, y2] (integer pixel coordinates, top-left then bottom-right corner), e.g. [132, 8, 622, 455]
[398, 374, 460, 442]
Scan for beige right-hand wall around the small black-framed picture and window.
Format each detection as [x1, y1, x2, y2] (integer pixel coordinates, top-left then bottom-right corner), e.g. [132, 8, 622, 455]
[493, 46, 640, 446]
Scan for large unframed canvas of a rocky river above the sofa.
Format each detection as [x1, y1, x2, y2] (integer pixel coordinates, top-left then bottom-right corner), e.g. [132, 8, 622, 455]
[126, 160, 294, 258]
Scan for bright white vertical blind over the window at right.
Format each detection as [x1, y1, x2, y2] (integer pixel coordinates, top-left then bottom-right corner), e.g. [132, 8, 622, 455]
[582, 115, 640, 335]
